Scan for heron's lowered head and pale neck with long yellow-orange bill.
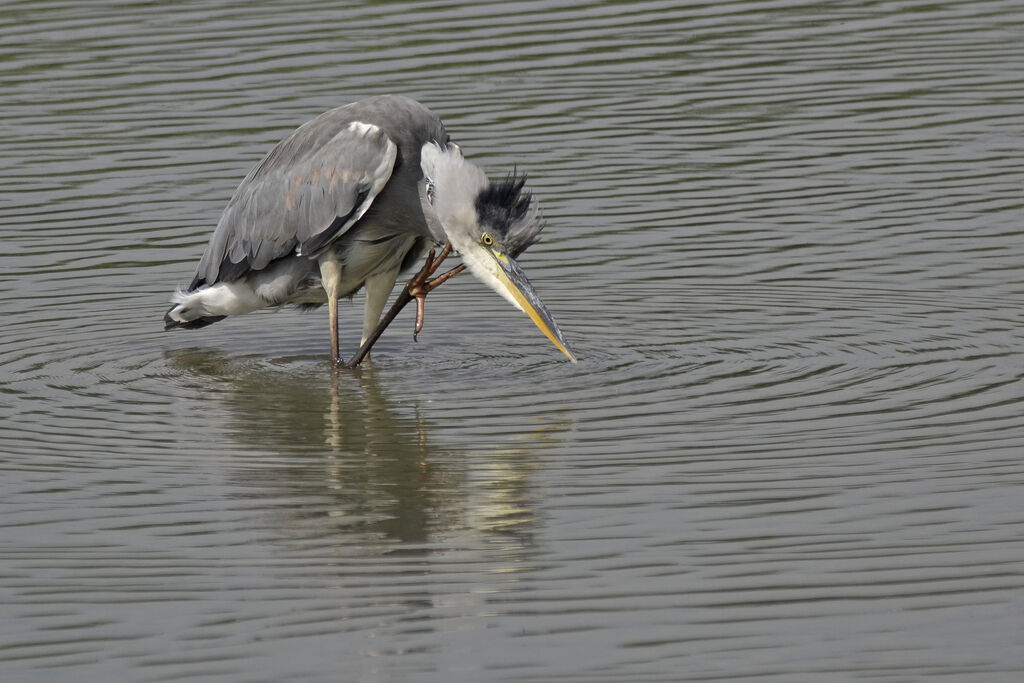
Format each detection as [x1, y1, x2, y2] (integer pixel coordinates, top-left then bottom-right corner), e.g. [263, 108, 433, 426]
[421, 143, 577, 362]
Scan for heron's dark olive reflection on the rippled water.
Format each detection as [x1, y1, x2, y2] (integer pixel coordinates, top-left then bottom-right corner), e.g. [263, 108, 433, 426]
[167, 349, 565, 552]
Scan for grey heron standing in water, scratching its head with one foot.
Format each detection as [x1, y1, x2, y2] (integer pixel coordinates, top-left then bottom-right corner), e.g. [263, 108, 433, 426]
[164, 95, 575, 362]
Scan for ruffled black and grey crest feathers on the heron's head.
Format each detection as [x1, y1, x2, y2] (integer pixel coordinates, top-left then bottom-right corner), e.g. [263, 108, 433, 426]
[476, 171, 544, 258]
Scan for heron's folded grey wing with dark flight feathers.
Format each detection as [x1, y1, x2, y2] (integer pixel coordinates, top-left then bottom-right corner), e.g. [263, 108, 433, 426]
[188, 119, 397, 291]
